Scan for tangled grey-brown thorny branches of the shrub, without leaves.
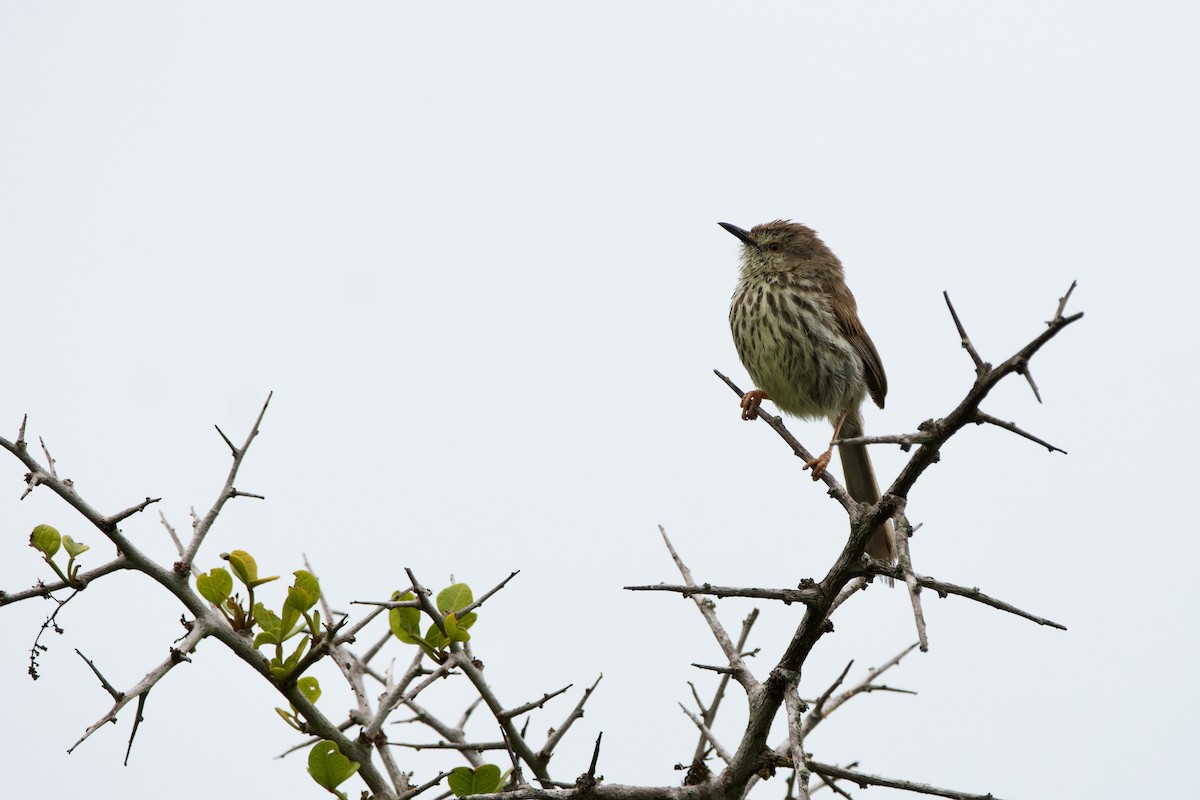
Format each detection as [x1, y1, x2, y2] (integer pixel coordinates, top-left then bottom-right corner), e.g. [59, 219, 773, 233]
[0, 284, 1082, 800]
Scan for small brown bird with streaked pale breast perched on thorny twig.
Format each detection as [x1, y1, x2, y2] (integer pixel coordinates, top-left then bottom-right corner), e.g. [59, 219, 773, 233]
[720, 219, 895, 564]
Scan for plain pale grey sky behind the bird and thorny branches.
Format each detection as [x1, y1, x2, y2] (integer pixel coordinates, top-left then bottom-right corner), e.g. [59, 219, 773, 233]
[0, 1, 1200, 800]
